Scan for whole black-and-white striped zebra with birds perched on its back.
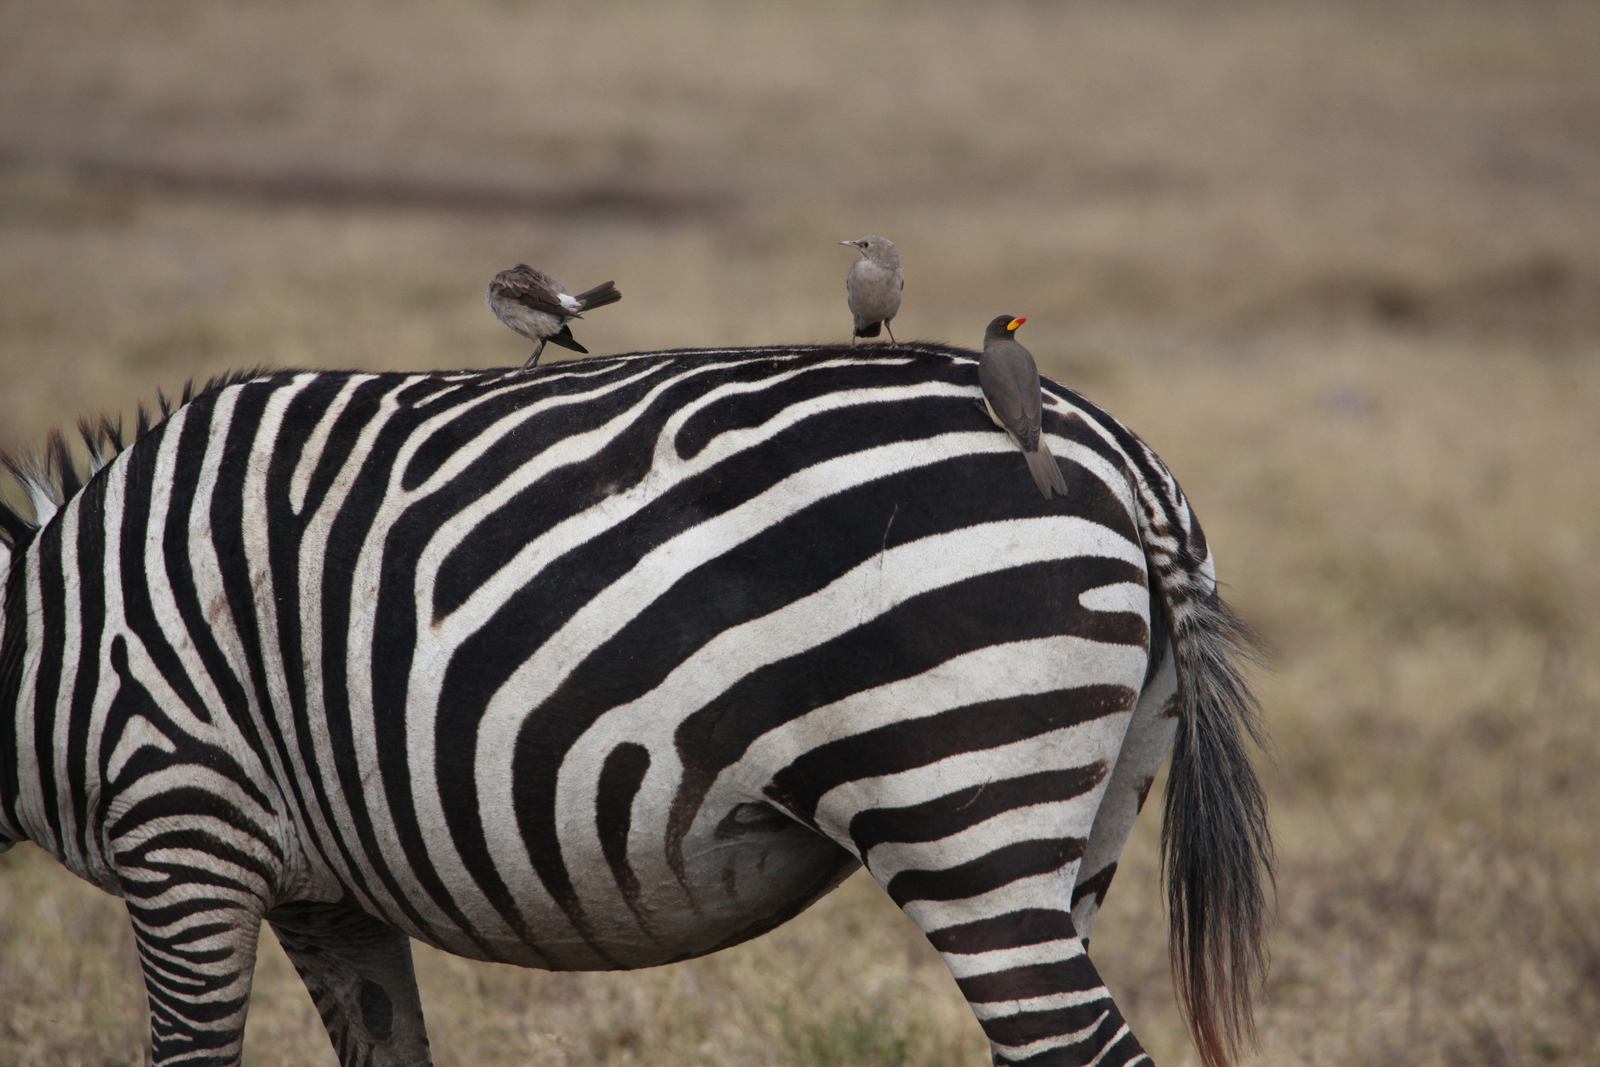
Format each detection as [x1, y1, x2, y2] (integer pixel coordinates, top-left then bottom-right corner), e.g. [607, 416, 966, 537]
[0, 342, 1272, 1067]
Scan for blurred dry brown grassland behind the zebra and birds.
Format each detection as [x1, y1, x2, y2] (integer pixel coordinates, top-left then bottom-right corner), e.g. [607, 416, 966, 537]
[0, 0, 1600, 1067]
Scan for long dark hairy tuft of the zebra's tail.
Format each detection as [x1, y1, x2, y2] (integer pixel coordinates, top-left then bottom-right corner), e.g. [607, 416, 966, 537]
[1152, 518, 1274, 1067]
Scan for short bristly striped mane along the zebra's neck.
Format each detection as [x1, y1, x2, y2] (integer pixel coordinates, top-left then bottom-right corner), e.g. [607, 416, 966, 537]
[0, 368, 264, 553]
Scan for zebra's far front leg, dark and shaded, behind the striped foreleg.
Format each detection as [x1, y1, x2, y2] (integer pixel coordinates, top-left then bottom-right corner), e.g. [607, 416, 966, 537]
[267, 902, 434, 1067]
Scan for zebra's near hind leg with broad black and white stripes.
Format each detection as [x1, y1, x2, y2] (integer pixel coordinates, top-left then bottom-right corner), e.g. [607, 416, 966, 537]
[819, 758, 1149, 1067]
